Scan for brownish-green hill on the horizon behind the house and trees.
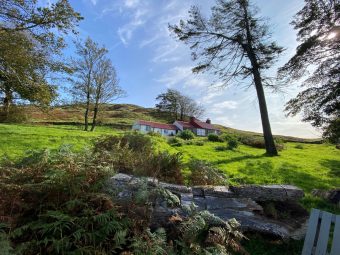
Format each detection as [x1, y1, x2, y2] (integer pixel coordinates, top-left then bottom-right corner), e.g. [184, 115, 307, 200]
[24, 104, 321, 143]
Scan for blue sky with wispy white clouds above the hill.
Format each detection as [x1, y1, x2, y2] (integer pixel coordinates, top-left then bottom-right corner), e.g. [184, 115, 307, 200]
[56, 0, 320, 138]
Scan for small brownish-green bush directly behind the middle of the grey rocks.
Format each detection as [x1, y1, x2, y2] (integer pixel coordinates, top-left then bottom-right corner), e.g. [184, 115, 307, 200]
[188, 159, 227, 185]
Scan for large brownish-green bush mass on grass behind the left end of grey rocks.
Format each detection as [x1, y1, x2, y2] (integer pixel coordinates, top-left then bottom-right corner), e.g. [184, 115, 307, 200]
[94, 132, 183, 184]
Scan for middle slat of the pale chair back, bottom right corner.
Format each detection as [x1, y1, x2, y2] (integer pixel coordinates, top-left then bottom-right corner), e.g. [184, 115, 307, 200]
[315, 212, 332, 255]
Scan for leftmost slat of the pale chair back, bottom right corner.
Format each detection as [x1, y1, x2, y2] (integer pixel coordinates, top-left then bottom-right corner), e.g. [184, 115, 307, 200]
[302, 209, 320, 255]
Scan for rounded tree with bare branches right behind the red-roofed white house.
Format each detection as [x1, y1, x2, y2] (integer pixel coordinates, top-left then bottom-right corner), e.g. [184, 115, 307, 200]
[156, 89, 204, 120]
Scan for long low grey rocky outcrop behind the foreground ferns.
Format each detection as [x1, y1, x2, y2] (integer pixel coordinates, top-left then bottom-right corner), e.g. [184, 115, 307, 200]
[109, 174, 307, 239]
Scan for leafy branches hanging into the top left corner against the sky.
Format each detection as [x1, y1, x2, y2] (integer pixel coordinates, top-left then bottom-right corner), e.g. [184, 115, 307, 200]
[0, 0, 83, 48]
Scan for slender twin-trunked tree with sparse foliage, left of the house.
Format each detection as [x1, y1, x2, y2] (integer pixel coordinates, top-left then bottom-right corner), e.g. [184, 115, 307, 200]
[70, 38, 124, 131]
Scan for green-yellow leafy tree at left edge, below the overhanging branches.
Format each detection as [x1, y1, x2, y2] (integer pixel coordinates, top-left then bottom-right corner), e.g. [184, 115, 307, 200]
[0, 29, 56, 117]
